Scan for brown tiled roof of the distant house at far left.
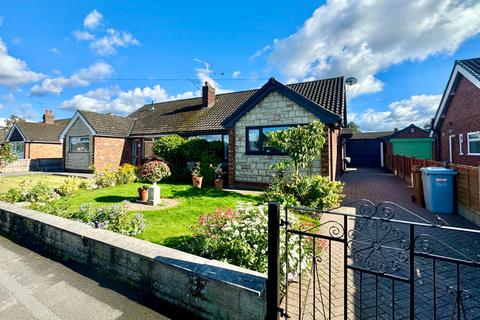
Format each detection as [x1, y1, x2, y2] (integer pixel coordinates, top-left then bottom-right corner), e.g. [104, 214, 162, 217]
[6, 121, 65, 143]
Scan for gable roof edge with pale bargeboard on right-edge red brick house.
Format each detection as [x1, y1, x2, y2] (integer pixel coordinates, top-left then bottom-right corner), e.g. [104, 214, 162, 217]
[430, 58, 480, 137]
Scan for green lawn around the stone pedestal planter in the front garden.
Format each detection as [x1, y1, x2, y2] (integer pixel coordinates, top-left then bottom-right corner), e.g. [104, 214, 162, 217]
[57, 183, 259, 246]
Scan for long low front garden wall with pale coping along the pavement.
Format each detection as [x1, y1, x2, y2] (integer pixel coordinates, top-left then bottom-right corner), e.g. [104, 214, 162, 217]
[0, 202, 266, 319]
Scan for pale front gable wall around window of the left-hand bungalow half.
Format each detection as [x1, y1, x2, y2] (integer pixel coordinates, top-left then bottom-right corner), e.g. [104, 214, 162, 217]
[63, 119, 93, 170]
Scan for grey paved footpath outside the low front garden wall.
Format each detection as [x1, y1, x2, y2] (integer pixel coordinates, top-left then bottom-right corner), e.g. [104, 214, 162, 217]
[0, 237, 168, 320]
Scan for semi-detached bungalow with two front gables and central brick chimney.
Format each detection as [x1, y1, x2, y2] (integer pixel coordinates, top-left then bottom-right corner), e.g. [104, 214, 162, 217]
[60, 77, 346, 185]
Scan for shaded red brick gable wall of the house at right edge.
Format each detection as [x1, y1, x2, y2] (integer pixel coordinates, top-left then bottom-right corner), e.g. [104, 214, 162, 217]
[438, 76, 480, 166]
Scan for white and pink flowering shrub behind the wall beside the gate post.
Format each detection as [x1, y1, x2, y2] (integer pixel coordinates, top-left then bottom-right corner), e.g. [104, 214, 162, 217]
[178, 203, 311, 280]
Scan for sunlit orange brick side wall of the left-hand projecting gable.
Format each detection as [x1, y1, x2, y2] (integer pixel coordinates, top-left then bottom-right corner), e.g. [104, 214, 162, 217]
[93, 136, 132, 170]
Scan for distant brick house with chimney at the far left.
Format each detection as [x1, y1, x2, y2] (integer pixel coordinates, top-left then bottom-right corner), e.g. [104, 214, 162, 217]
[5, 110, 65, 159]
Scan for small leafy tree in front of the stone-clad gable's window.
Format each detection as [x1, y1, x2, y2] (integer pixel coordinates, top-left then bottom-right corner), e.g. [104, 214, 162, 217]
[268, 121, 325, 180]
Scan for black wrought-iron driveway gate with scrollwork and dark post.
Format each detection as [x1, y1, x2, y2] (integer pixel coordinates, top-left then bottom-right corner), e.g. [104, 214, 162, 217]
[267, 200, 480, 319]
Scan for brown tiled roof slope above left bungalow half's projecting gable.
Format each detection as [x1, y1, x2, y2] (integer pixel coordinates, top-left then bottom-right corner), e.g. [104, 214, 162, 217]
[78, 110, 135, 137]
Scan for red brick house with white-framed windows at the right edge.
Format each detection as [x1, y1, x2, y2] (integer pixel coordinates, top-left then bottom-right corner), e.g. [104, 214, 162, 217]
[430, 58, 480, 166]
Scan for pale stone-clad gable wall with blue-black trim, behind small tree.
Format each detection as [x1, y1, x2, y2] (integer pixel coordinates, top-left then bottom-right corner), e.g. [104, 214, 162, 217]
[235, 92, 321, 183]
